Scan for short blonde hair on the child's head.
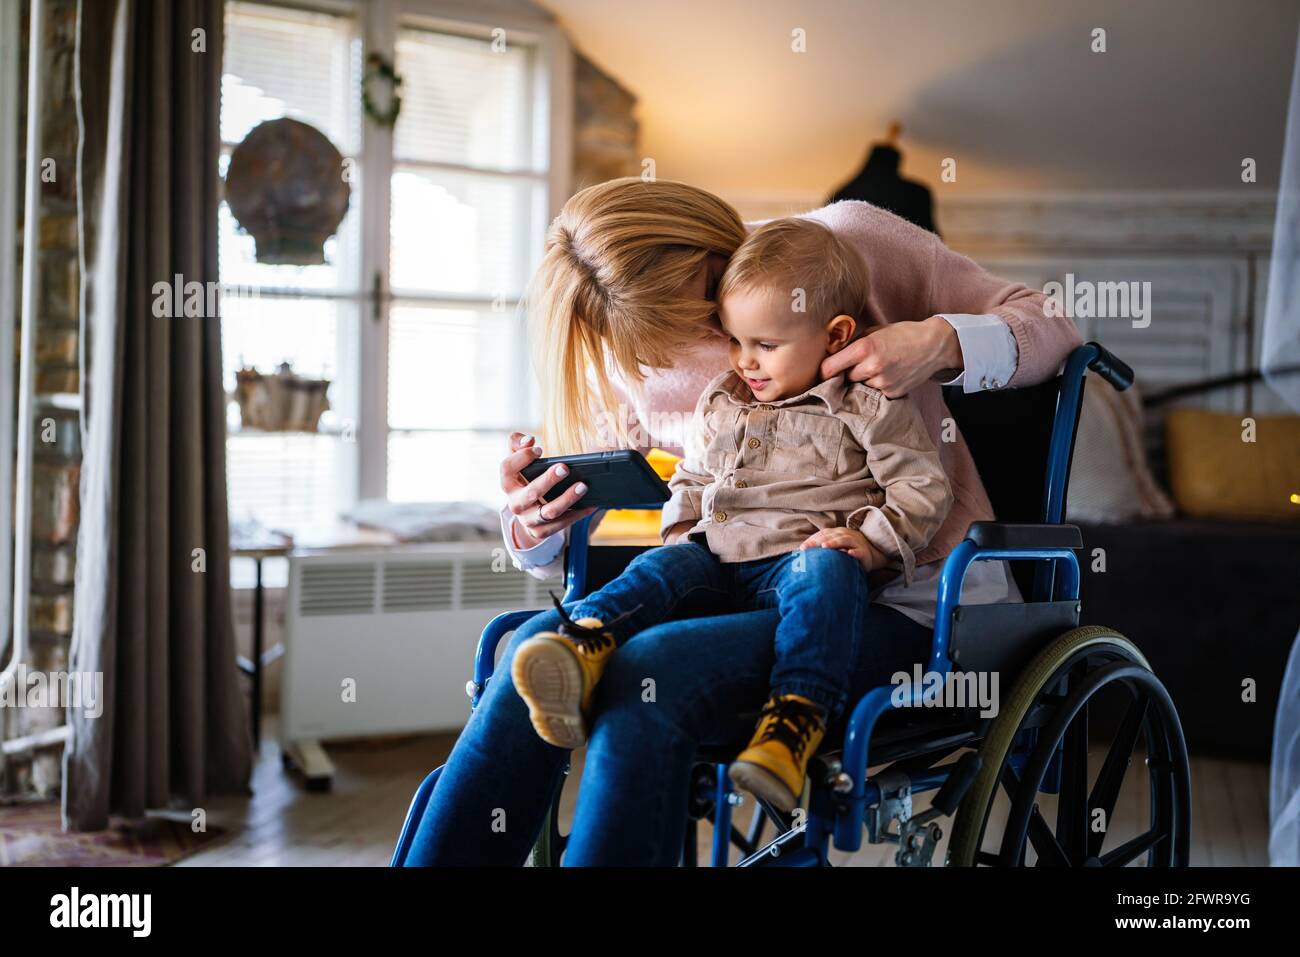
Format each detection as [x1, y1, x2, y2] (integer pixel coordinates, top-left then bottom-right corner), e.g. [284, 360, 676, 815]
[718, 217, 871, 335]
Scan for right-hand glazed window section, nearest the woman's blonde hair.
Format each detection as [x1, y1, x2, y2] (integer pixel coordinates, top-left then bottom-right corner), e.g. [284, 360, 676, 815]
[386, 27, 547, 501]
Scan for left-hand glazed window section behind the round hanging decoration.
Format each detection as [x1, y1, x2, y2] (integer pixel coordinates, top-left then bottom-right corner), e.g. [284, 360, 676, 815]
[218, 3, 363, 528]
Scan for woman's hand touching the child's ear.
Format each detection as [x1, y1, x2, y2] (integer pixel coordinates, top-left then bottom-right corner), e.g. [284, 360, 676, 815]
[822, 316, 965, 399]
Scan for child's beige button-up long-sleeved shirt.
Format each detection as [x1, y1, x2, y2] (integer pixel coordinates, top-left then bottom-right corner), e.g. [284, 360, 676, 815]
[660, 372, 953, 584]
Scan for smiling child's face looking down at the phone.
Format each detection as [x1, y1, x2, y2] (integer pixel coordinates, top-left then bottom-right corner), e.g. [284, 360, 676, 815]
[718, 289, 854, 402]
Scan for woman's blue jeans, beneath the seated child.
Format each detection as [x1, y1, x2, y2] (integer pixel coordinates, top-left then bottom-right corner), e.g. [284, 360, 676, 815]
[407, 546, 931, 866]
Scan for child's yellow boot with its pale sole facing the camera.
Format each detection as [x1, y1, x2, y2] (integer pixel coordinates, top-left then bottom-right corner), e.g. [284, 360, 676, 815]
[510, 602, 616, 749]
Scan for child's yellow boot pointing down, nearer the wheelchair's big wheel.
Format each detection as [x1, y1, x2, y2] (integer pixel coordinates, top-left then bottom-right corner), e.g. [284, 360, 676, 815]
[727, 694, 826, 814]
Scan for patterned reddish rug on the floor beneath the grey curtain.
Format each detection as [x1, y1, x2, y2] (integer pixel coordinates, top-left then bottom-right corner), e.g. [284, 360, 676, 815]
[0, 802, 224, 867]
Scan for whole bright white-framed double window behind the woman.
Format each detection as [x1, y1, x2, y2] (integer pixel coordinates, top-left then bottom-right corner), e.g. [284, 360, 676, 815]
[220, 0, 569, 546]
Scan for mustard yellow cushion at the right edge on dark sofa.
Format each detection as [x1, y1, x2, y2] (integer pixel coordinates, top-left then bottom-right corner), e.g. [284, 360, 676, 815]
[1165, 408, 1300, 521]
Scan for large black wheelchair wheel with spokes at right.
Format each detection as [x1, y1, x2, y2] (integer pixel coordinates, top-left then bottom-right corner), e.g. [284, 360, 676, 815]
[948, 625, 1191, 867]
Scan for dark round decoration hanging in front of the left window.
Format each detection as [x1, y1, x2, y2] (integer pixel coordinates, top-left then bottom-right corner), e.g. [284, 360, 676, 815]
[226, 117, 352, 265]
